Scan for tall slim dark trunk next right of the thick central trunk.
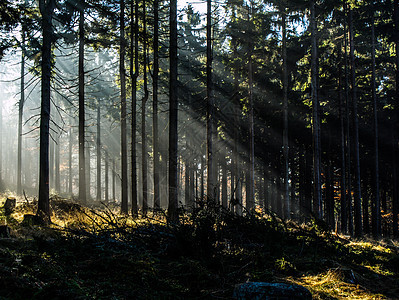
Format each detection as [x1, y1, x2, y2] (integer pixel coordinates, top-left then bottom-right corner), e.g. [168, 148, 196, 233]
[206, 0, 216, 199]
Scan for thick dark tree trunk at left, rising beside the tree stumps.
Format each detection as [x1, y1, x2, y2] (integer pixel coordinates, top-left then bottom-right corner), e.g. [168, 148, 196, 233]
[37, 0, 55, 222]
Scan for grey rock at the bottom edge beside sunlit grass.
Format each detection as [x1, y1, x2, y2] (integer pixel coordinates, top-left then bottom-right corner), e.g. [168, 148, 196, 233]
[233, 282, 312, 300]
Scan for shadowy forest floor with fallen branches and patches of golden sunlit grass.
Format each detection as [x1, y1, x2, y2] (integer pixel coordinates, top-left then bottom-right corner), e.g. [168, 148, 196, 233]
[0, 195, 399, 299]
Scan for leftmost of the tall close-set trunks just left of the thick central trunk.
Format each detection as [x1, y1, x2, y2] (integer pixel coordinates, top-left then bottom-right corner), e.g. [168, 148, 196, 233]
[119, 0, 129, 215]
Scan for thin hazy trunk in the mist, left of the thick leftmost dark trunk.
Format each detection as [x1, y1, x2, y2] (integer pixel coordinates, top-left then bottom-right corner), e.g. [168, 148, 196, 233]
[17, 25, 25, 195]
